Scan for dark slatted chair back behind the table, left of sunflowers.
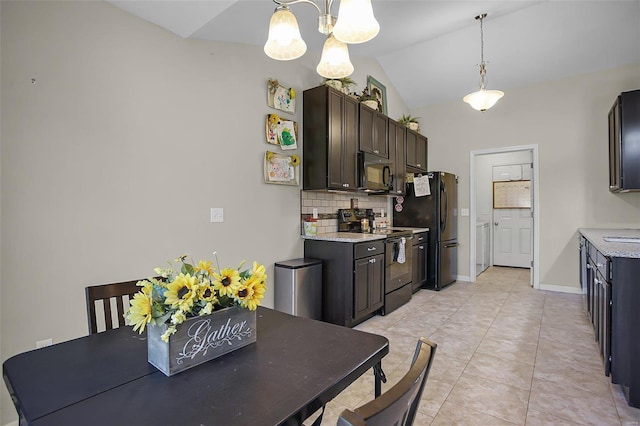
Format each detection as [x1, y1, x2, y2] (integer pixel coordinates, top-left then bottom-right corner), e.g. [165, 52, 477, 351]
[85, 280, 140, 334]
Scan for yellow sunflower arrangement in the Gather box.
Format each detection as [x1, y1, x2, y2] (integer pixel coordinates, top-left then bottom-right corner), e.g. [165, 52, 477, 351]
[126, 252, 267, 342]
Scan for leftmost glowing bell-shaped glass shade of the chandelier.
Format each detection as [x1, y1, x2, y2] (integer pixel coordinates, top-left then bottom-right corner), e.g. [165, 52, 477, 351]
[264, 6, 307, 61]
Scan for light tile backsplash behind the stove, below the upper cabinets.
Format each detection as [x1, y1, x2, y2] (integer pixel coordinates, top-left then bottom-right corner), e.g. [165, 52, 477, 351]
[300, 191, 392, 234]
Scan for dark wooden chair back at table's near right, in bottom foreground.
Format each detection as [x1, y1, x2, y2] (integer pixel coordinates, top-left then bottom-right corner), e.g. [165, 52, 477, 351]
[338, 337, 438, 426]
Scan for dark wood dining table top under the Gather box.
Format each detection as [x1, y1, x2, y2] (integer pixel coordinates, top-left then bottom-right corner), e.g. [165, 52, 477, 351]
[3, 307, 389, 426]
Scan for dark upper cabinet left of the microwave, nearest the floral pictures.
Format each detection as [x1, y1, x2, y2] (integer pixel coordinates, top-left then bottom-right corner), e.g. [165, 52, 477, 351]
[302, 86, 359, 191]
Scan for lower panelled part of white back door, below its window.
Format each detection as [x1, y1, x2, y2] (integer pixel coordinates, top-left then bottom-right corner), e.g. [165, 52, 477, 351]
[493, 209, 533, 268]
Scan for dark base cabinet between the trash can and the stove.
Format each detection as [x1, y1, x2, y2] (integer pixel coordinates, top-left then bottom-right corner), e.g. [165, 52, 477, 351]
[304, 239, 384, 327]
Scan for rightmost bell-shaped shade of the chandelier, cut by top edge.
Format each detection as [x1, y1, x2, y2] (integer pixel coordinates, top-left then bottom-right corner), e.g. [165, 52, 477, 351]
[333, 0, 380, 44]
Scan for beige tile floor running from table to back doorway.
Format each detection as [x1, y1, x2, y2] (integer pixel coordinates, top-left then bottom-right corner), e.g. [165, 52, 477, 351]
[305, 267, 640, 426]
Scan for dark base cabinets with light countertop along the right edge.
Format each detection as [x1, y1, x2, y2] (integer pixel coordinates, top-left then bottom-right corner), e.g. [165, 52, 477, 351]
[579, 229, 640, 408]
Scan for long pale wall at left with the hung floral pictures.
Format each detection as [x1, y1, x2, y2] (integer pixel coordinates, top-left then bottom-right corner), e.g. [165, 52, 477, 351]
[0, 1, 406, 424]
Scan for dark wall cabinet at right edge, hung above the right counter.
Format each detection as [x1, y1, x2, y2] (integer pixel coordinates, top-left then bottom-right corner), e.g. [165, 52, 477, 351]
[609, 90, 640, 192]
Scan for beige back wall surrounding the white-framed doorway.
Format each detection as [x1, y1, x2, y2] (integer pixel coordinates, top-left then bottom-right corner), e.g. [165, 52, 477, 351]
[412, 64, 640, 291]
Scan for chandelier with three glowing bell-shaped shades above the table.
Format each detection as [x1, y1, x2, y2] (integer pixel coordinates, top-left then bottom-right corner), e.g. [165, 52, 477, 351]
[264, 0, 380, 78]
